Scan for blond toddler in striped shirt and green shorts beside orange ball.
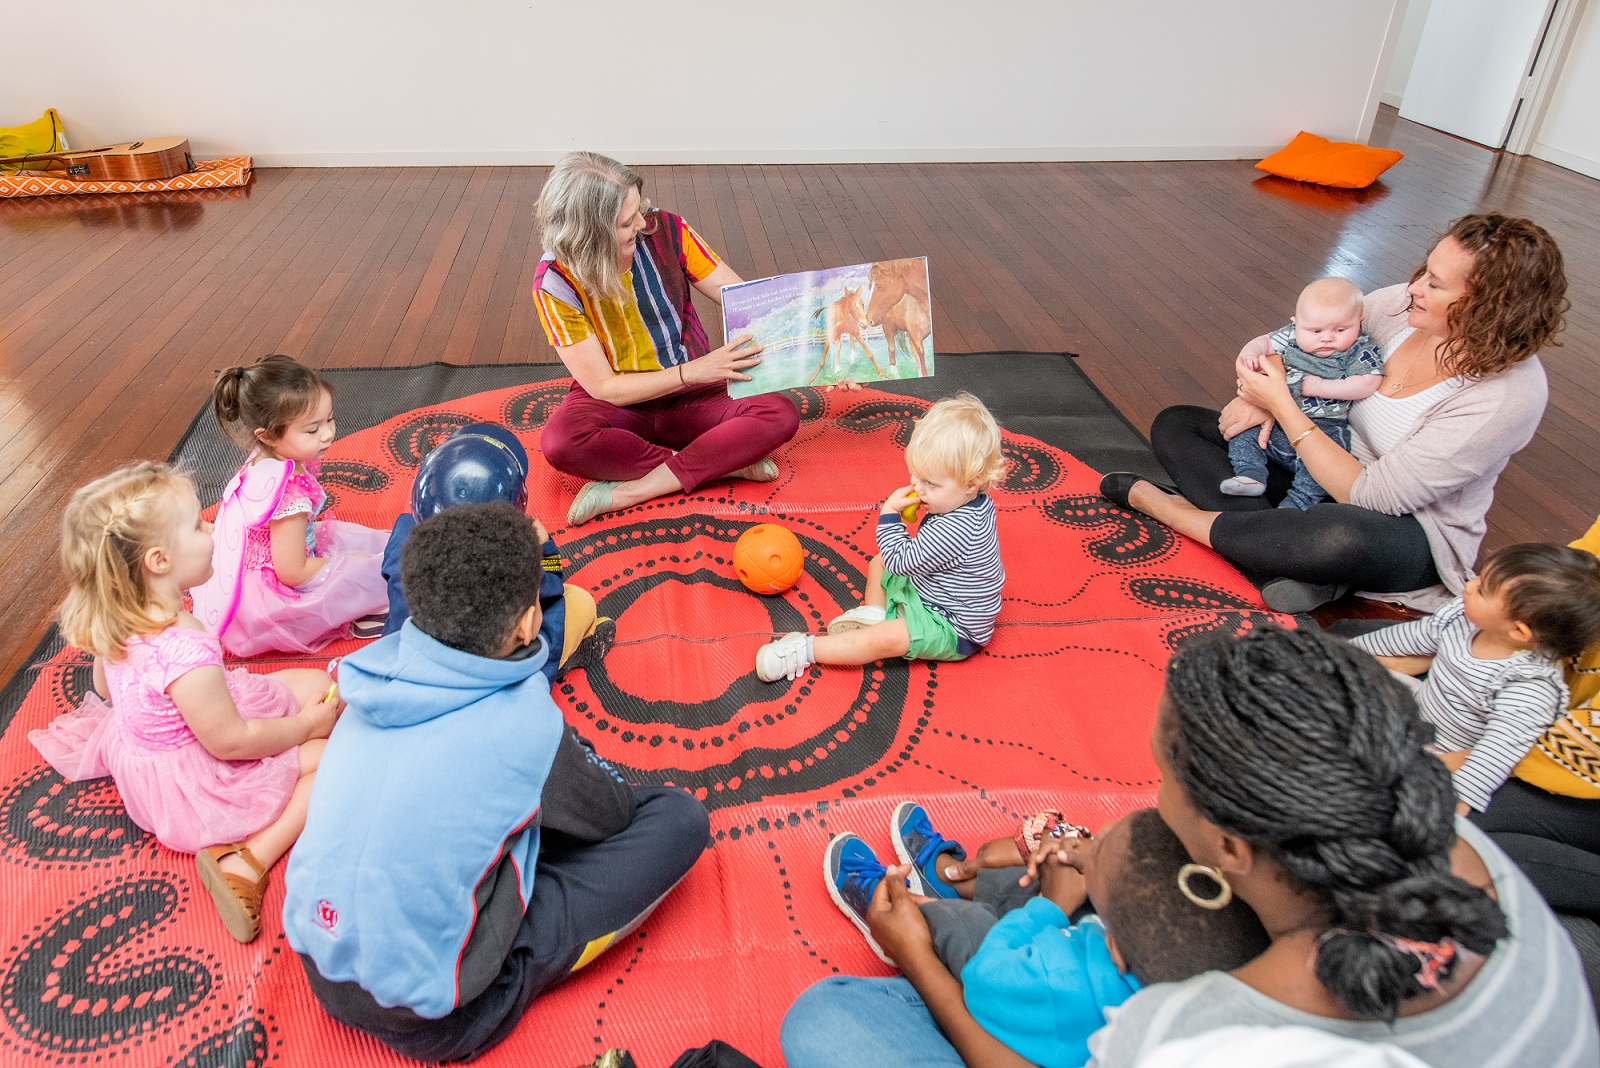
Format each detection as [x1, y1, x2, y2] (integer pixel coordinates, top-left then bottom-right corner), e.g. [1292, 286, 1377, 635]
[755, 393, 1006, 683]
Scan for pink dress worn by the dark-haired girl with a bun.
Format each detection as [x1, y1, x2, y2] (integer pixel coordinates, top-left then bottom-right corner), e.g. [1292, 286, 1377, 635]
[194, 459, 389, 657]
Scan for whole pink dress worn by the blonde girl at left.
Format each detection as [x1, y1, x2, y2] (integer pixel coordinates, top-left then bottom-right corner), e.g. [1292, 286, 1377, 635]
[27, 627, 299, 852]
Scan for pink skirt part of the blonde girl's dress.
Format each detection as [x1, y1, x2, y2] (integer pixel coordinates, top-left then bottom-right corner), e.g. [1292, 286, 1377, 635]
[27, 668, 299, 852]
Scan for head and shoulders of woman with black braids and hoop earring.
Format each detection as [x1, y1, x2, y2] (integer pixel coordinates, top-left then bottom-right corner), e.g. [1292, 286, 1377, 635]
[1090, 628, 1600, 1068]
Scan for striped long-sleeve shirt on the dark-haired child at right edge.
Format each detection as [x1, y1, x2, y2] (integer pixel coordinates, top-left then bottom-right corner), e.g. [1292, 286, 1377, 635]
[1355, 596, 1566, 812]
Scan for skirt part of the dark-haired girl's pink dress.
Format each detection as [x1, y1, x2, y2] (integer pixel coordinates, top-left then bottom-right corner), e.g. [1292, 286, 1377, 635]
[222, 520, 389, 657]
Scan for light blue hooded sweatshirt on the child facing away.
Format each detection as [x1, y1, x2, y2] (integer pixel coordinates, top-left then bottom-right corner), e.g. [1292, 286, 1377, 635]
[283, 622, 563, 1018]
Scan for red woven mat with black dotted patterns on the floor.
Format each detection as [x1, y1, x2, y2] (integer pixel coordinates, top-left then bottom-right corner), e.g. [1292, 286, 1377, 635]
[0, 381, 1274, 1068]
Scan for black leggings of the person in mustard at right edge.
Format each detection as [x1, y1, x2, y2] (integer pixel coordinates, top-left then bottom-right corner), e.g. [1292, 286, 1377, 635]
[1472, 779, 1600, 921]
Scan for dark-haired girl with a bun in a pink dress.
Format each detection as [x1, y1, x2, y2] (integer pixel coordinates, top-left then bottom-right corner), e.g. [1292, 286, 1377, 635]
[195, 355, 389, 657]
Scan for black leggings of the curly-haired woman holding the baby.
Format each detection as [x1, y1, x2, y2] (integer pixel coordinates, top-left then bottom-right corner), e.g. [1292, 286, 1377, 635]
[1150, 404, 1438, 593]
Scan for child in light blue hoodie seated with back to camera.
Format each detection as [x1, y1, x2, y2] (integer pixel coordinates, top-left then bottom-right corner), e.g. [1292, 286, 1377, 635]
[283, 504, 709, 1060]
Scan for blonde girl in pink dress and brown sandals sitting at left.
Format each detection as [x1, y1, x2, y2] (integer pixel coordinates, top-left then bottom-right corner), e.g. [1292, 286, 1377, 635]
[29, 462, 342, 942]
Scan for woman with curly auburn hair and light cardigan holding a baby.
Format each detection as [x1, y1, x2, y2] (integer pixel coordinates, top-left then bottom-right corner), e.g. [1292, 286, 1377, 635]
[1101, 213, 1568, 612]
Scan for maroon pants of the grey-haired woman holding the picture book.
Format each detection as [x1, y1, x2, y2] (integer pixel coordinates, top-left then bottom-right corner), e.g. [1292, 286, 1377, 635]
[539, 382, 800, 491]
